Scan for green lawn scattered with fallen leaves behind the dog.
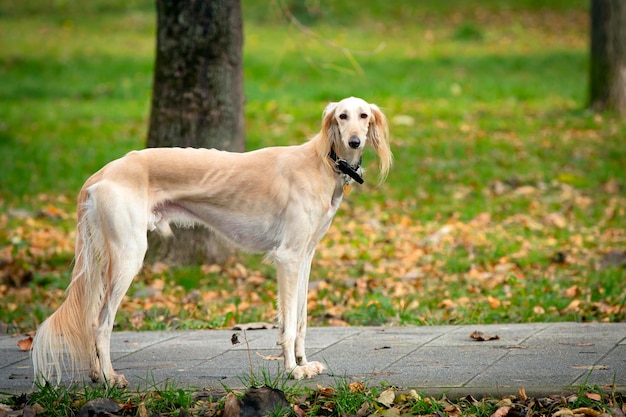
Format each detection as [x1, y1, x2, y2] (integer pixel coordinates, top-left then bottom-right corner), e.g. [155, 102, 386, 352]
[0, 0, 626, 332]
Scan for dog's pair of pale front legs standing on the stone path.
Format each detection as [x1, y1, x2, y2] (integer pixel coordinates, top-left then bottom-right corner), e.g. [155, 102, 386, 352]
[276, 249, 325, 379]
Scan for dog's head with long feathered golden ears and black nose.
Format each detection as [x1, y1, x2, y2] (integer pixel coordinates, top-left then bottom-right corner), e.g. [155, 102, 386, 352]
[321, 97, 393, 180]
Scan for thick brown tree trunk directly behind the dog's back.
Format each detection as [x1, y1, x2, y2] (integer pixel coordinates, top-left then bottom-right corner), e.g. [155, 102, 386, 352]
[147, 0, 245, 265]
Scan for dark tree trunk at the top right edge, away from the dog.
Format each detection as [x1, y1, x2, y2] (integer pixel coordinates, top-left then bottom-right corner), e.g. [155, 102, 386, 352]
[589, 0, 626, 114]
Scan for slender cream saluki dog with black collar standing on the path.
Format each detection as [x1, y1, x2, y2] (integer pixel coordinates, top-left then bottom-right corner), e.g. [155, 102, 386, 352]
[31, 97, 393, 386]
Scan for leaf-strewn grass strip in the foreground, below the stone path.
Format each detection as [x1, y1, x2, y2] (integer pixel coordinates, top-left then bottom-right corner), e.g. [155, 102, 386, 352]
[0, 373, 624, 417]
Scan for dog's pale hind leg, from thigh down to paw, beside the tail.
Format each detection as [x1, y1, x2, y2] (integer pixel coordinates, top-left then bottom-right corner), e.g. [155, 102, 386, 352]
[89, 184, 148, 386]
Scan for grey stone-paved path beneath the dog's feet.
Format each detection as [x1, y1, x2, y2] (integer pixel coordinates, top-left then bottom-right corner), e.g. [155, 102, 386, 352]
[0, 323, 626, 397]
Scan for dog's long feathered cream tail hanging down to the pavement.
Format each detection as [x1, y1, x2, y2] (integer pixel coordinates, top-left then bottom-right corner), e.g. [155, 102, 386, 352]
[31, 188, 109, 384]
